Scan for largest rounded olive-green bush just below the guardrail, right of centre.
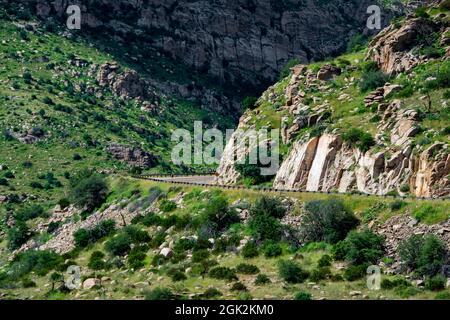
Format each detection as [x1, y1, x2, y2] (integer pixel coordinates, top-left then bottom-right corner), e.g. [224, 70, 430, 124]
[300, 199, 358, 243]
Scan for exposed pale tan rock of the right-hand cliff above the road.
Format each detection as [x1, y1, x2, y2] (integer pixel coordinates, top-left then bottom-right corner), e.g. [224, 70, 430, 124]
[218, 8, 450, 197]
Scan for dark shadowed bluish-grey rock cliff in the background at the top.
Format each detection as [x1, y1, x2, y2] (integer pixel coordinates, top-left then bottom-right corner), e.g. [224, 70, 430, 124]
[29, 0, 390, 90]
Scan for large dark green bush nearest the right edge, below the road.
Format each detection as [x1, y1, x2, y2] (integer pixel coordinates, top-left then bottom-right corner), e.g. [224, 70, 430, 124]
[398, 234, 447, 277]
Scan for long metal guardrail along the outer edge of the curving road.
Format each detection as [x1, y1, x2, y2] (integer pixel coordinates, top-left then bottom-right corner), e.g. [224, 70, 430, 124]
[132, 173, 450, 201]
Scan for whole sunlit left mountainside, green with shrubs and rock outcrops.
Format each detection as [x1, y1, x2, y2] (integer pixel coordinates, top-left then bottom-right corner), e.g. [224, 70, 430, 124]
[0, 20, 234, 211]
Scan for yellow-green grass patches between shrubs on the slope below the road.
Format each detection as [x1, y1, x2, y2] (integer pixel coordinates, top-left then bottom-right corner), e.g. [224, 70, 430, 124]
[1, 177, 449, 299]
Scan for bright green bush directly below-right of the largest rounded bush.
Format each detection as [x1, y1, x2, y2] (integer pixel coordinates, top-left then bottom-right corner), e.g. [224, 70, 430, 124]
[333, 230, 384, 265]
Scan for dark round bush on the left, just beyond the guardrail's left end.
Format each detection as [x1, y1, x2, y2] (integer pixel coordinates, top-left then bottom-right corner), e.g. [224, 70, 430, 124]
[70, 172, 109, 212]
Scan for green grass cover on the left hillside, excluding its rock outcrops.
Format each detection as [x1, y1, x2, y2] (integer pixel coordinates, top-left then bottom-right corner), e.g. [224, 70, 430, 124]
[0, 20, 236, 212]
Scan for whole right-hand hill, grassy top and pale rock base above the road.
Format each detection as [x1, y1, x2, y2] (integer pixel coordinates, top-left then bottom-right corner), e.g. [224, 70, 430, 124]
[218, 3, 450, 197]
